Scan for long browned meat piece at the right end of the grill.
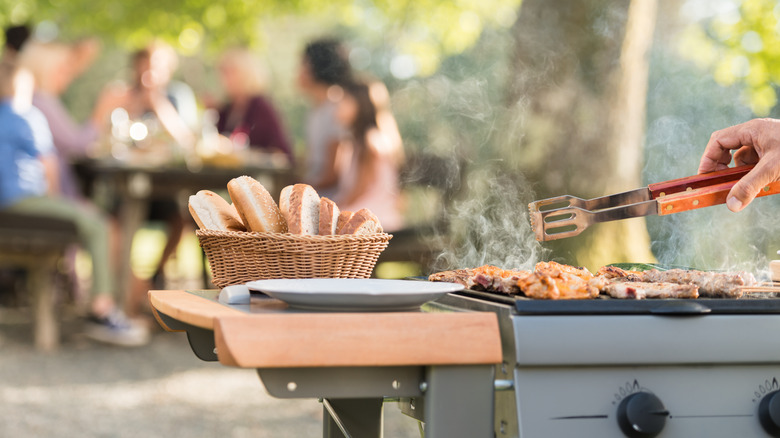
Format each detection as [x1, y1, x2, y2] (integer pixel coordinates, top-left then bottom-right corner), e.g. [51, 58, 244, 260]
[640, 269, 756, 298]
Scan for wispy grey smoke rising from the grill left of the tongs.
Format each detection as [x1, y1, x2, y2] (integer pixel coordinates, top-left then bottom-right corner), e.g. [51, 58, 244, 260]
[437, 162, 546, 269]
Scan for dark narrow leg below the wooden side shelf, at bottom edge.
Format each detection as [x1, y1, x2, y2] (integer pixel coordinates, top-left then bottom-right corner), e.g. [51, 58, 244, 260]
[322, 398, 384, 438]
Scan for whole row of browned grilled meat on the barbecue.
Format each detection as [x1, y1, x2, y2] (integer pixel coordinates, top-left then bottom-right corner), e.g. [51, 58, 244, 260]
[428, 262, 756, 299]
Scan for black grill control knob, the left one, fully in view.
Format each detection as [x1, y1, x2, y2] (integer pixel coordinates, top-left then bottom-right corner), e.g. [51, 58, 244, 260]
[617, 392, 669, 438]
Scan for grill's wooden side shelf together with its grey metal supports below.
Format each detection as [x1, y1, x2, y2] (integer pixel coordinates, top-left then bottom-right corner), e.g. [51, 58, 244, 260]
[149, 290, 501, 438]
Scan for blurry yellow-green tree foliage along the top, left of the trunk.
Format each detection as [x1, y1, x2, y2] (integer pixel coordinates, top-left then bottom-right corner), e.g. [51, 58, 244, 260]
[0, 0, 520, 75]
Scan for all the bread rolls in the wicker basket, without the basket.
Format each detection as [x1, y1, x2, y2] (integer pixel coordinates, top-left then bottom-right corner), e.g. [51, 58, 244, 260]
[189, 176, 384, 235]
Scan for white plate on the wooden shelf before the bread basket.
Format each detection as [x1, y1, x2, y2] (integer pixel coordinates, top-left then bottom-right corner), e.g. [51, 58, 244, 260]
[247, 278, 463, 311]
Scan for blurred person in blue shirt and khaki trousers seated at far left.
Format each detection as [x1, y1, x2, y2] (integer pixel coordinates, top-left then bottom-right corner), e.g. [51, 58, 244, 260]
[0, 62, 149, 346]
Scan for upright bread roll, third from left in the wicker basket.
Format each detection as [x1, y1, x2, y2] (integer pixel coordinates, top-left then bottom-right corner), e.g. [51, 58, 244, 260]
[279, 184, 320, 235]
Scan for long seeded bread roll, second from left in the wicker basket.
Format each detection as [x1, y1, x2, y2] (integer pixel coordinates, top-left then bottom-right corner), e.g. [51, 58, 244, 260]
[228, 176, 287, 233]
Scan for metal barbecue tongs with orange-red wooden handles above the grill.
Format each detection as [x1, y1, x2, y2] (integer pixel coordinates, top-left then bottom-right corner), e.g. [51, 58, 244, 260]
[528, 165, 780, 241]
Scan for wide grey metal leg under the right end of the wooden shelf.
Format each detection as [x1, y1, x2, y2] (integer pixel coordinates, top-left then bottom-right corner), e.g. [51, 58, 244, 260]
[424, 365, 495, 438]
